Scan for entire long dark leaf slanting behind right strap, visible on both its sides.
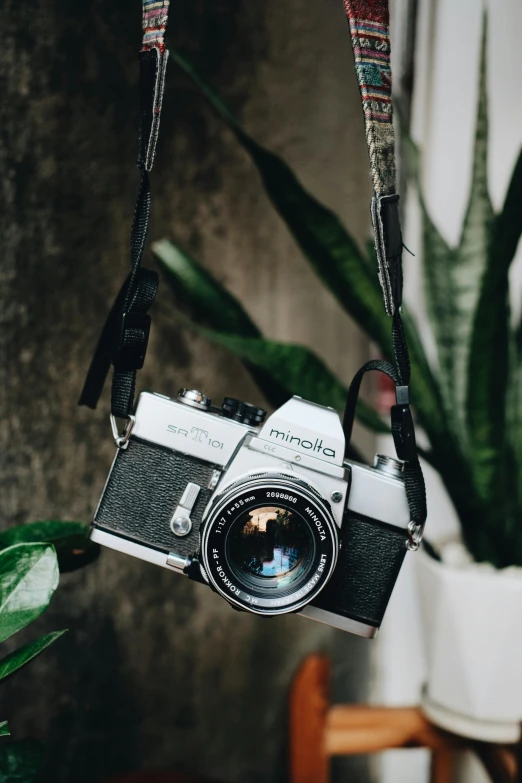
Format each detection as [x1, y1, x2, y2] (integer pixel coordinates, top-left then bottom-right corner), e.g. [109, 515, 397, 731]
[167, 50, 480, 532]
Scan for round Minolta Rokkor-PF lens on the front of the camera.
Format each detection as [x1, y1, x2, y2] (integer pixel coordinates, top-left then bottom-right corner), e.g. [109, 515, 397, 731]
[201, 474, 337, 614]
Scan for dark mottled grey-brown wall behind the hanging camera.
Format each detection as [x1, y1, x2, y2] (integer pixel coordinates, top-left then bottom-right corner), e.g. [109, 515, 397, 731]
[0, 0, 369, 783]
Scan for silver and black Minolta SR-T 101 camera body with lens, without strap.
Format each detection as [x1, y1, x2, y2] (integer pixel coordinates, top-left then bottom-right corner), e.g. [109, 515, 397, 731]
[91, 390, 410, 637]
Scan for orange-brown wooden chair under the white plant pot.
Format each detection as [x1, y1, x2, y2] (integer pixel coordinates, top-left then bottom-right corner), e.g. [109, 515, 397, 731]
[289, 655, 522, 783]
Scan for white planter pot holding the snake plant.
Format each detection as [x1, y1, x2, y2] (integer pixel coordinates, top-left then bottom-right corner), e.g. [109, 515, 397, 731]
[416, 551, 522, 742]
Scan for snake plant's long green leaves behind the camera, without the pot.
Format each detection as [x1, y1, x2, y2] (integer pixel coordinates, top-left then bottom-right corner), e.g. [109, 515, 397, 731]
[153, 35, 522, 567]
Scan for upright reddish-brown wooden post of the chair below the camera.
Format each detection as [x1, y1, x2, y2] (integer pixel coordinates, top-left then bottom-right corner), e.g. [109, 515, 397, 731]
[289, 655, 330, 783]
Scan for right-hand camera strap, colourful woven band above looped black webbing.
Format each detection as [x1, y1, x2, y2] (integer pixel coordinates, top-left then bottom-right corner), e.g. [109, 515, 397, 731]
[343, 0, 427, 549]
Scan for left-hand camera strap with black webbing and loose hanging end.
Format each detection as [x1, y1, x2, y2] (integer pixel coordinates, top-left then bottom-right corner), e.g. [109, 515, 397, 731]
[79, 0, 170, 432]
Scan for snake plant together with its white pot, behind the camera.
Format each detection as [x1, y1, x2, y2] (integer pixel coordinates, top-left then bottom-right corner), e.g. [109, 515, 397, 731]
[153, 29, 522, 740]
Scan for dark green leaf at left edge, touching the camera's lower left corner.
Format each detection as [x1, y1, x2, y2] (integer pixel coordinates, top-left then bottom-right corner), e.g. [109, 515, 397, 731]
[0, 520, 100, 573]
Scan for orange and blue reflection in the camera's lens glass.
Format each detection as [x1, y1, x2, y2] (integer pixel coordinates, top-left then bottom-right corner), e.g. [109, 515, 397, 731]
[228, 506, 315, 586]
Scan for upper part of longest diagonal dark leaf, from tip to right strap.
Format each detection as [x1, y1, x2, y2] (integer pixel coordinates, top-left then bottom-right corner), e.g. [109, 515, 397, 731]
[170, 49, 390, 353]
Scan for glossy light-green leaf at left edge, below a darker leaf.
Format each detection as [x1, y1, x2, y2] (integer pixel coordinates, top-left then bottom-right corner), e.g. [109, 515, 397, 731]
[0, 544, 59, 642]
